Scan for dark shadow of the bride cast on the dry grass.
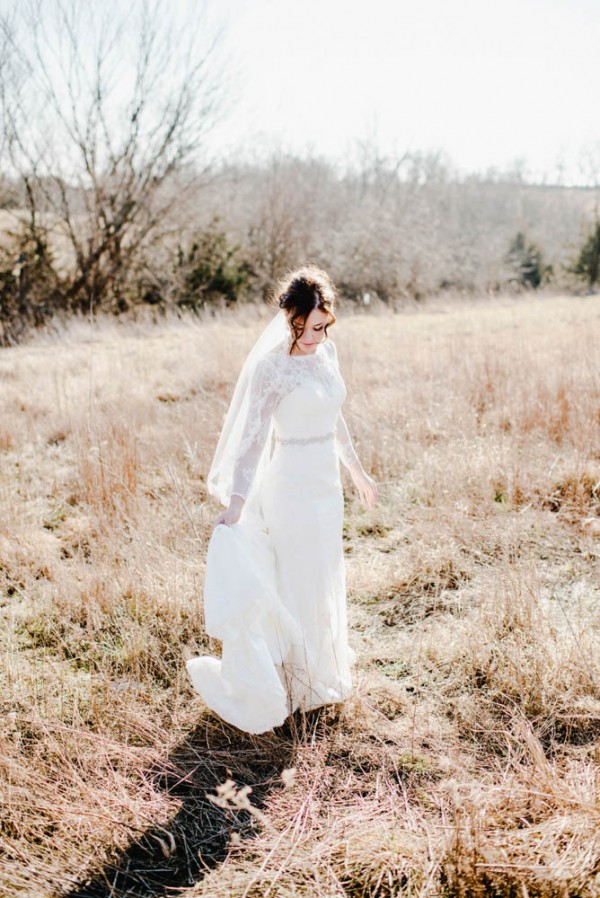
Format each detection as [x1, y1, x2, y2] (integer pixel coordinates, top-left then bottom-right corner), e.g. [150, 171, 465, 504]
[61, 711, 319, 898]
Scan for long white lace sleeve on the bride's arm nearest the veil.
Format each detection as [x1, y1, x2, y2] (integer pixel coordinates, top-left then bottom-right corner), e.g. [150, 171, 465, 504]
[231, 359, 279, 499]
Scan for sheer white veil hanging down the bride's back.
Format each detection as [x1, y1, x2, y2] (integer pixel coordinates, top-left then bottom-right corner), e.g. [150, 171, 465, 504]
[207, 311, 289, 505]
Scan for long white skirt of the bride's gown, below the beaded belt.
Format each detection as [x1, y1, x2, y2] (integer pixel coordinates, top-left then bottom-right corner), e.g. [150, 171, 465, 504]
[187, 440, 352, 733]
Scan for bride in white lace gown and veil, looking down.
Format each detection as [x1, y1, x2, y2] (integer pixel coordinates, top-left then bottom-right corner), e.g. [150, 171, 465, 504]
[187, 266, 377, 733]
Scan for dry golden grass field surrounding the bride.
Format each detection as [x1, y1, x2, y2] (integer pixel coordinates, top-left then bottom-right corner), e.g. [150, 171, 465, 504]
[0, 297, 600, 898]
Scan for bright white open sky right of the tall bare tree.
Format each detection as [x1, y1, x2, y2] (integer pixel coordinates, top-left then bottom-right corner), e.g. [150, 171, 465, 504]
[208, 0, 600, 180]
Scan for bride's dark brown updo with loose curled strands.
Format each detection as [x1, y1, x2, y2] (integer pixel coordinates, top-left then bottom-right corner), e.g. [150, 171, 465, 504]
[275, 265, 337, 354]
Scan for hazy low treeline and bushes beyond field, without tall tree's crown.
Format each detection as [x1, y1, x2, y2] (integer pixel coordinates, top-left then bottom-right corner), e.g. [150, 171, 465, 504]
[0, 154, 600, 345]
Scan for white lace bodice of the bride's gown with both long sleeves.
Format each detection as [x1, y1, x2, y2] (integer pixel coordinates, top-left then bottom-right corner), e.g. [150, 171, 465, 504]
[232, 340, 358, 498]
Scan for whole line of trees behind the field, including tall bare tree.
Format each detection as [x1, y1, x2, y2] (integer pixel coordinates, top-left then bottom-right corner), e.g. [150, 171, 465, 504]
[0, 0, 600, 345]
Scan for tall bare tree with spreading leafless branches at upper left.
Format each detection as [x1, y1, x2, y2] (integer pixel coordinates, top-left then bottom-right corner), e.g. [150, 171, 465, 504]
[0, 0, 225, 318]
